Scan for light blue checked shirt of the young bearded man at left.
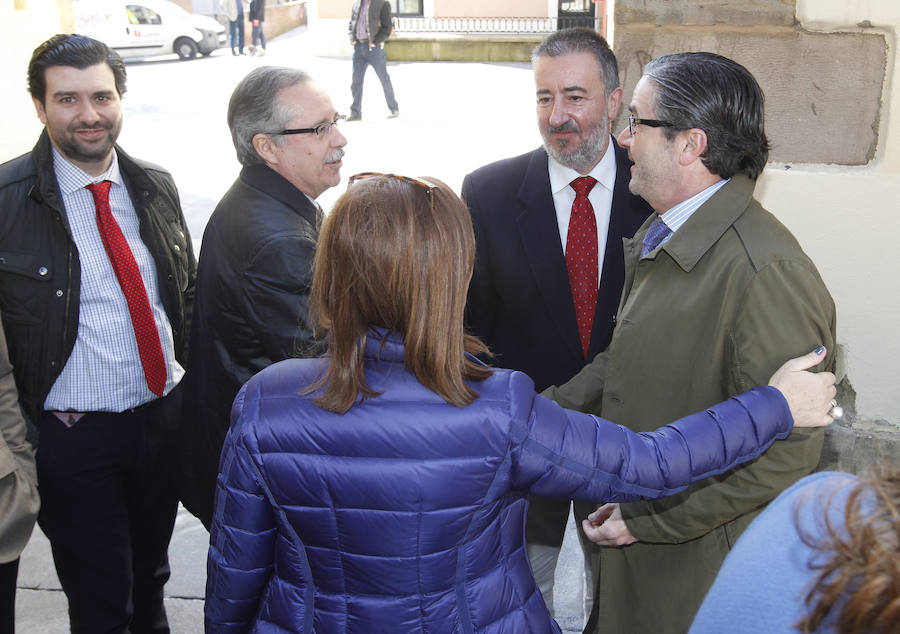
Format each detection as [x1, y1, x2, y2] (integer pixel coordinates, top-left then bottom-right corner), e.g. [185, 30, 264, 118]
[44, 147, 184, 412]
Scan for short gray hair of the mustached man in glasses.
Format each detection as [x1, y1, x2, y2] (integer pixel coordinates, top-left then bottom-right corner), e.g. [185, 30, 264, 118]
[228, 66, 311, 165]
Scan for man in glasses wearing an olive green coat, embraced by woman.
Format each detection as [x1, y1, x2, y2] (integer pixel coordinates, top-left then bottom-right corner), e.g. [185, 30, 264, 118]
[545, 53, 836, 634]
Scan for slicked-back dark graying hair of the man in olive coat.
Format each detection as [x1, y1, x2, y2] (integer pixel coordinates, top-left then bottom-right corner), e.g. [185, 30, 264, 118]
[644, 53, 769, 180]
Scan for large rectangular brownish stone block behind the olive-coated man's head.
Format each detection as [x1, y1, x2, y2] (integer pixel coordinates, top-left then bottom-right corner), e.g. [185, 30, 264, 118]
[615, 29, 887, 165]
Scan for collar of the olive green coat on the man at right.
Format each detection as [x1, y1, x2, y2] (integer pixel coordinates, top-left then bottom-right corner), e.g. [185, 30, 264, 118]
[652, 174, 756, 272]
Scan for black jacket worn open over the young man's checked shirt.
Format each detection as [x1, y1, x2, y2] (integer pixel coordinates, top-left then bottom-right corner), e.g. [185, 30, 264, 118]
[0, 130, 197, 421]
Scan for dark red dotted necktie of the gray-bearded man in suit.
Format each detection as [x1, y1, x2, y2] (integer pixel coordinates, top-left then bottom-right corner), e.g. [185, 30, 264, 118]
[566, 176, 598, 359]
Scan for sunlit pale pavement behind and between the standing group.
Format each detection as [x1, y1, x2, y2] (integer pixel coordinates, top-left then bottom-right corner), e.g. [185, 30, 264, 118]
[15, 27, 581, 634]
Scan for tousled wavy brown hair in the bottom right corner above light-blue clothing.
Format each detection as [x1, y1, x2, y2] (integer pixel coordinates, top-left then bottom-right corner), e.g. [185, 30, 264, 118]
[796, 471, 900, 634]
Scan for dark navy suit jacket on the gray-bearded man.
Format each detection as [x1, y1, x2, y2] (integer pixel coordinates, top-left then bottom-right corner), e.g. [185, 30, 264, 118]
[462, 140, 652, 391]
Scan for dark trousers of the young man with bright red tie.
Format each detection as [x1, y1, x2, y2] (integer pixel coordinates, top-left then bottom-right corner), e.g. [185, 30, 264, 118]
[37, 389, 180, 634]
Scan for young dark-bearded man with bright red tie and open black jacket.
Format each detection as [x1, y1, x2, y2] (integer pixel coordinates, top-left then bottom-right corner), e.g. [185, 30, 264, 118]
[0, 35, 196, 633]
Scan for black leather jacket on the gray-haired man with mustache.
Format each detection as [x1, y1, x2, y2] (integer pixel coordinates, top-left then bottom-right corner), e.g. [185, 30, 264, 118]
[179, 165, 320, 527]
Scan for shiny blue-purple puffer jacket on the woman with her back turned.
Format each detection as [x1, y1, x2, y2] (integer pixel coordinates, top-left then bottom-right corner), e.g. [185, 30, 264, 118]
[206, 335, 792, 634]
